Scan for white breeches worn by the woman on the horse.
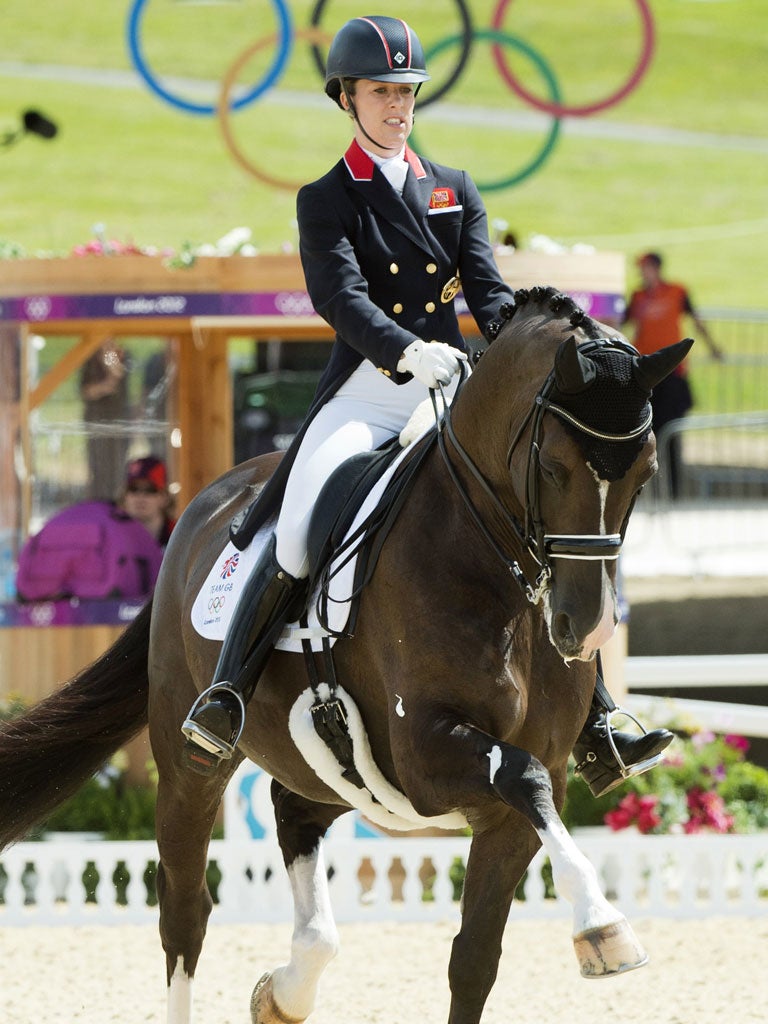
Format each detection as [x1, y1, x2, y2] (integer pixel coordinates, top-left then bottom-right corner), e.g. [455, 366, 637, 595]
[275, 359, 459, 579]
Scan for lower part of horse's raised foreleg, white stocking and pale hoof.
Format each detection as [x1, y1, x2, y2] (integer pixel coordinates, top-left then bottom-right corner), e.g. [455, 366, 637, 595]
[487, 742, 648, 978]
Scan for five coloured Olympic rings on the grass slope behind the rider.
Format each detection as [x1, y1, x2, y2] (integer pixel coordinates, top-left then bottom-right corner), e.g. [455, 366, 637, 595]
[126, 0, 655, 193]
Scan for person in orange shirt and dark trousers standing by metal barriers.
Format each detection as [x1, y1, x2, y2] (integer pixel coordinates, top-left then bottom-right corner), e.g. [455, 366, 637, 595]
[624, 253, 723, 498]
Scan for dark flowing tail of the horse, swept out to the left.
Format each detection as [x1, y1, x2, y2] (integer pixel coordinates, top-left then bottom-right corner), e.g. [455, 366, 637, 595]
[0, 601, 152, 849]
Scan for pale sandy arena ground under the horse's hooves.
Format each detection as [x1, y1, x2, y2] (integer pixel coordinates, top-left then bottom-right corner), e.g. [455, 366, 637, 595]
[0, 918, 768, 1024]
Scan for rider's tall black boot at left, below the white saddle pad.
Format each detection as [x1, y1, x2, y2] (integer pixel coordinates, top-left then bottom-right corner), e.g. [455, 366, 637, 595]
[181, 537, 301, 775]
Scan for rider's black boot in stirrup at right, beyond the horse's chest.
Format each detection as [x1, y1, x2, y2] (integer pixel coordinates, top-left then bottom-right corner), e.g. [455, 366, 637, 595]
[573, 660, 675, 797]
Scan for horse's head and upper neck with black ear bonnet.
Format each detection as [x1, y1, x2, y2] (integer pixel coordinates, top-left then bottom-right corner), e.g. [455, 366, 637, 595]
[460, 289, 692, 660]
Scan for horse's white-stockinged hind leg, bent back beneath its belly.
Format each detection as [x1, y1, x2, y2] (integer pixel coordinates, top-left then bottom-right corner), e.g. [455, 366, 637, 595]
[251, 781, 348, 1024]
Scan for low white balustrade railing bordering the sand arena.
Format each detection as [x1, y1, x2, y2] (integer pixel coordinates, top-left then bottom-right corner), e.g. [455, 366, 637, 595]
[0, 829, 768, 926]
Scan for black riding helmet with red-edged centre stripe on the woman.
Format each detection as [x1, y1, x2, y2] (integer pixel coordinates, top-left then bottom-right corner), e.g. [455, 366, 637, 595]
[326, 15, 429, 106]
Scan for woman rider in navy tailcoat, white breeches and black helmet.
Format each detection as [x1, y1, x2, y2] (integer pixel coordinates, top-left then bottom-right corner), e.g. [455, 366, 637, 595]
[182, 16, 672, 798]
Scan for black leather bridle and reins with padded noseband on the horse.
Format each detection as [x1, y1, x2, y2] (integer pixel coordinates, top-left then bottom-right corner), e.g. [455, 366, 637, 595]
[430, 338, 652, 604]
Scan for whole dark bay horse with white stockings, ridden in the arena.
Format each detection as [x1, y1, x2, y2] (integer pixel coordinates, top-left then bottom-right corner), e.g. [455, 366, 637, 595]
[0, 289, 690, 1024]
